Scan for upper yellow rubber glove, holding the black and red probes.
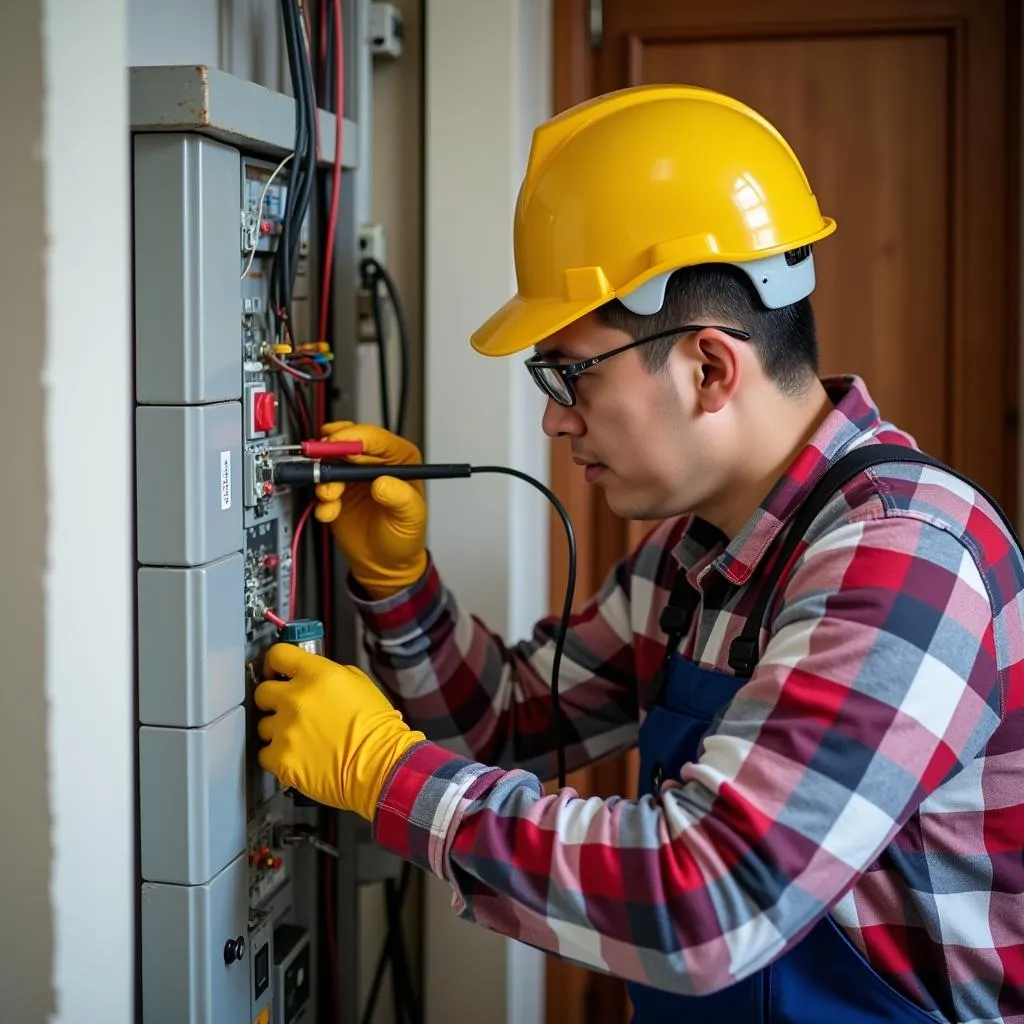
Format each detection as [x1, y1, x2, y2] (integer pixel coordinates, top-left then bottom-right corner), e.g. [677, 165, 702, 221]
[315, 422, 427, 600]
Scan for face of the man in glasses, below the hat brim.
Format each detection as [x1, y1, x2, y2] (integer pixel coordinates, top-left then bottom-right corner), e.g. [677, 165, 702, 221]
[537, 313, 715, 519]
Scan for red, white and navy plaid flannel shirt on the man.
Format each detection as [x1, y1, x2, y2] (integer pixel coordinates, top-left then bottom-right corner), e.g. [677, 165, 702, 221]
[353, 377, 1024, 1022]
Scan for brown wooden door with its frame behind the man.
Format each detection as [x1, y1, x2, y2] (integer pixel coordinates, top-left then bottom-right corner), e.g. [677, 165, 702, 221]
[548, 0, 1021, 1024]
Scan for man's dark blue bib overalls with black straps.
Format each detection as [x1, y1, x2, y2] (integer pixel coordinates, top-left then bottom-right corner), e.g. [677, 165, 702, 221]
[629, 444, 995, 1024]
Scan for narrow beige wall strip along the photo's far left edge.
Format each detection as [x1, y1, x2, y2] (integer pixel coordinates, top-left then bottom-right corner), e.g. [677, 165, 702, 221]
[0, 2, 54, 1020]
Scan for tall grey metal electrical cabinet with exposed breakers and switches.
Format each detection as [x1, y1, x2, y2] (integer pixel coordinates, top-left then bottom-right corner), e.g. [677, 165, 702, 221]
[130, 67, 356, 1024]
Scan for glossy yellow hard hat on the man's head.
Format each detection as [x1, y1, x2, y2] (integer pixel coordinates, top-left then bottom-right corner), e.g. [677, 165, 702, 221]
[471, 85, 836, 355]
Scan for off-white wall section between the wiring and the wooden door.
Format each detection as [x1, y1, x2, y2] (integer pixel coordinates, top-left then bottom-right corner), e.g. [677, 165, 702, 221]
[424, 0, 551, 1024]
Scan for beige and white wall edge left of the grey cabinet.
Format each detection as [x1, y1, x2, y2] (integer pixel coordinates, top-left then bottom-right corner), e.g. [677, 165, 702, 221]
[0, 0, 135, 1024]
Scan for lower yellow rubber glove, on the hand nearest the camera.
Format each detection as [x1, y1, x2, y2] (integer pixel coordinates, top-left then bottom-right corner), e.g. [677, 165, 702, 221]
[255, 643, 426, 821]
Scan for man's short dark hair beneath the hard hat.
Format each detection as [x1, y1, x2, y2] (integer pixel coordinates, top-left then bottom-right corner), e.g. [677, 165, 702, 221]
[597, 263, 818, 394]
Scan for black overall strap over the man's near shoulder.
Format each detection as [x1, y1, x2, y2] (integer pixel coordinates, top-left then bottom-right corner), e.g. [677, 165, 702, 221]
[729, 444, 1020, 678]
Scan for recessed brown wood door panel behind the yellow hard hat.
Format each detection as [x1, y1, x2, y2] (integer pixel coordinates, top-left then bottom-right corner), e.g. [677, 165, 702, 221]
[630, 32, 950, 459]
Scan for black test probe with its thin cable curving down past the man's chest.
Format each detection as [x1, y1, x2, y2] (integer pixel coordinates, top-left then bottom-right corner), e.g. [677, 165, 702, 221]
[273, 459, 577, 788]
